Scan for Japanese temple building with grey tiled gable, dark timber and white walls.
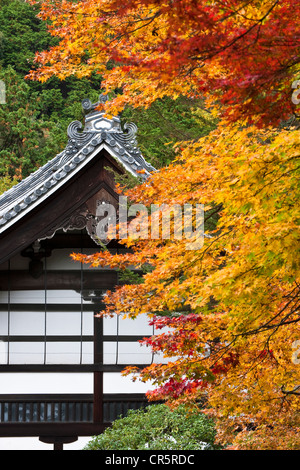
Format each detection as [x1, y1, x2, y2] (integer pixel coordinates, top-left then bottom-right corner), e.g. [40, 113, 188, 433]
[0, 95, 159, 450]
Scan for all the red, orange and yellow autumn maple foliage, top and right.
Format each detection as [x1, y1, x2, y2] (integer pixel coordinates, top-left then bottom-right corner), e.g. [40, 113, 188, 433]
[31, 0, 300, 449]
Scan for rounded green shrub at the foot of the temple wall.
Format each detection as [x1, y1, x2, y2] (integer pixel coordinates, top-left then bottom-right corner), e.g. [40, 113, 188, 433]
[84, 404, 220, 450]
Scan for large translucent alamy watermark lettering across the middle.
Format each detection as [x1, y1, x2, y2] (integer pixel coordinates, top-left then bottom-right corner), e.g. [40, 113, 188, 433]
[96, 196, 204, 250]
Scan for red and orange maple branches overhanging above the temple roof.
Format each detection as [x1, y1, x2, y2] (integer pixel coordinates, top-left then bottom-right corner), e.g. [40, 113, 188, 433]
[29, 0, 300, 123]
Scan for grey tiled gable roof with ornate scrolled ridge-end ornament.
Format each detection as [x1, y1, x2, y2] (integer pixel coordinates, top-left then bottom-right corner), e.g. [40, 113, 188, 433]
[0, 95, 155, 233]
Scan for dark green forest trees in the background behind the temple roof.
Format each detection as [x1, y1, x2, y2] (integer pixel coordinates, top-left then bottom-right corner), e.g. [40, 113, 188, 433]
[0, 0, 215, 189]
